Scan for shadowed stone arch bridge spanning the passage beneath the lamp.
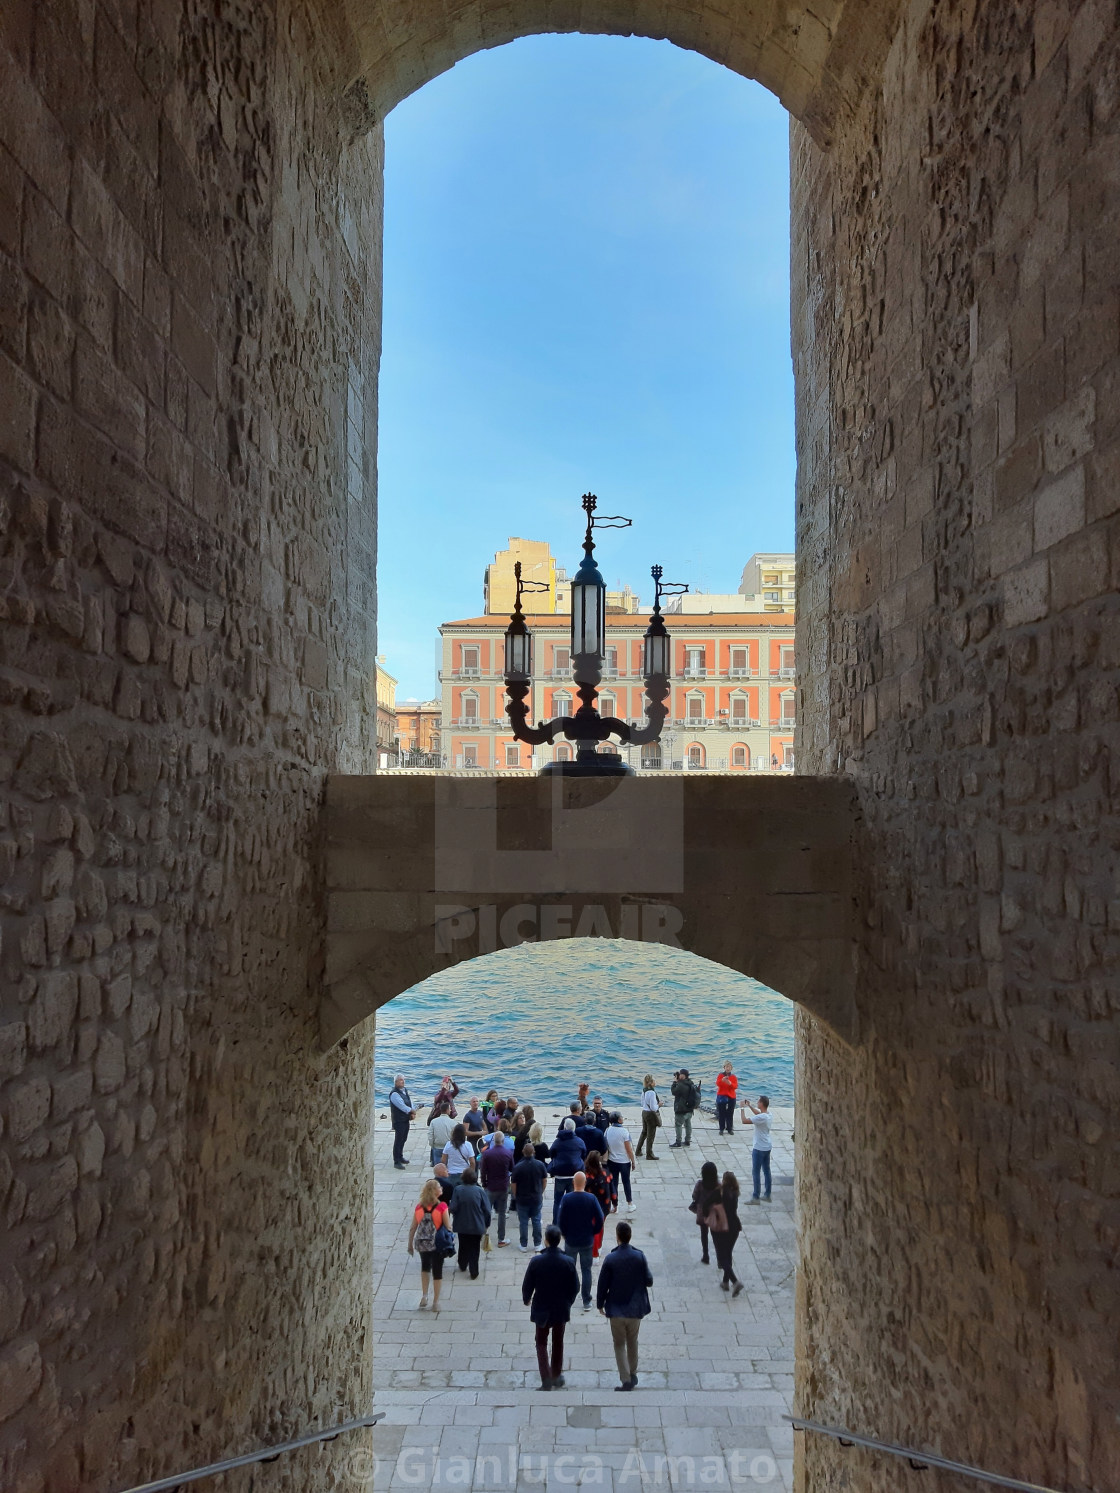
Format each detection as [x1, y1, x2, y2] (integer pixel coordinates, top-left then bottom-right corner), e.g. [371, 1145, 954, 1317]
[320, 776, 859, 1047]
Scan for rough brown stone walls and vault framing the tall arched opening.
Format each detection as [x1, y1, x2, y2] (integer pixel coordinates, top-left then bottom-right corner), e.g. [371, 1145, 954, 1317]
[0, 0, 1120, 1493]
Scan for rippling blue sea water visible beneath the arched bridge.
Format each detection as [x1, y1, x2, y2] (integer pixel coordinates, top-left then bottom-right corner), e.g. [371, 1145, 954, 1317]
[376, 939, 793, 1117]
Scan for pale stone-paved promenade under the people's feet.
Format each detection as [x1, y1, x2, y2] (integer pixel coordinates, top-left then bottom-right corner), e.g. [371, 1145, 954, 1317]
[368, 1108, 796, 1493]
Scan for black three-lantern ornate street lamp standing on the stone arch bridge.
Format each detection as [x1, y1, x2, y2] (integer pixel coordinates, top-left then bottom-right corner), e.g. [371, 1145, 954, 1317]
[505, 493, 688, 778]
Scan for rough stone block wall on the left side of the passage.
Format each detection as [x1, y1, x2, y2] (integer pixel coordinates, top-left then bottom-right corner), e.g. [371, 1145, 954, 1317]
[0, 0, 381, 1493]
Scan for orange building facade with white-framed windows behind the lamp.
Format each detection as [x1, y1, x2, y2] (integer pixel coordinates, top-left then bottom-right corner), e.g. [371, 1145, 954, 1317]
[439, 612, 797, 772]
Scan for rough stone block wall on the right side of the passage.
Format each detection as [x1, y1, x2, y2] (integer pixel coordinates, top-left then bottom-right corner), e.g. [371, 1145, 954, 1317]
[791, 0, 1120, 1493]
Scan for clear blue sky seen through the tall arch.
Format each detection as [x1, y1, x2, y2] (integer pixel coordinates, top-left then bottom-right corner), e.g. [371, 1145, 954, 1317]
[378, 36, 794, 696]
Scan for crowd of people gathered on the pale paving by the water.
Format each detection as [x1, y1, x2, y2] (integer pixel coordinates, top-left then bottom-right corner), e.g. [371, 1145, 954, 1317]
[390, 1062, 771, 1390]
